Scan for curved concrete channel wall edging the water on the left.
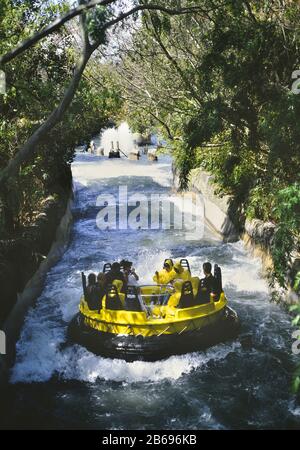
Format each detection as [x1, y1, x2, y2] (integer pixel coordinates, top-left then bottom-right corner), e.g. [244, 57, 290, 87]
[0, 196, 73, 386]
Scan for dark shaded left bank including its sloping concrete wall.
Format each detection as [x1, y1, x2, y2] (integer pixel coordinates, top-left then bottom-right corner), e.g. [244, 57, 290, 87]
[0, 181, 73, 384]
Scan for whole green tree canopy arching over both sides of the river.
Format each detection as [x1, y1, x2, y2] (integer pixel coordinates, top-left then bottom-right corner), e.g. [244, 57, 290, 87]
[0, 0, 300, 285]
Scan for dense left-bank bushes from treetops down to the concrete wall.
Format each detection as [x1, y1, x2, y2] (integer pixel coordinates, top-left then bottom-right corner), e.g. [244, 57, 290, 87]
[0, 0, 122, 322]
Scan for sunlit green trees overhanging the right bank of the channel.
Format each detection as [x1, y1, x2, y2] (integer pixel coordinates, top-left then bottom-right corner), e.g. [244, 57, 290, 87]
[120, 0, 300, 286]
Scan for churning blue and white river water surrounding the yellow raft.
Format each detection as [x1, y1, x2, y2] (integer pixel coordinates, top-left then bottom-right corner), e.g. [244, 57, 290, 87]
[2, 154, 300, 430]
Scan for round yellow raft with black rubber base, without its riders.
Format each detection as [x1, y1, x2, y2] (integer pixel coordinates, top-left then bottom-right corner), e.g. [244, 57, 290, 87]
[68, 259, 240, 362]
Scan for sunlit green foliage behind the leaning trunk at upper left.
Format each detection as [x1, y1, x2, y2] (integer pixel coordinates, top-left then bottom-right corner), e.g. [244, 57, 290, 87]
[0, 0, 122, 238]
